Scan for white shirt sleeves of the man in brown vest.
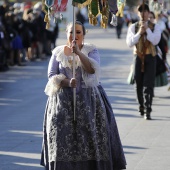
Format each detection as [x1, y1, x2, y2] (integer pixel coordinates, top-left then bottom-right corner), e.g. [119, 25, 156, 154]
[126, 23, 161, 47]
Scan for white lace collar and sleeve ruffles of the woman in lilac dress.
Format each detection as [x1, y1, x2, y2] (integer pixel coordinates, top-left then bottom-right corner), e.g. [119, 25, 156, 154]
[45, 43, 100, 96]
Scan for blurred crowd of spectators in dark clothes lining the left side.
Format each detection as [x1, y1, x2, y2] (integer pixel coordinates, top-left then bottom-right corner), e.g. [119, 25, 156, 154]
[0, 1, 59, 71]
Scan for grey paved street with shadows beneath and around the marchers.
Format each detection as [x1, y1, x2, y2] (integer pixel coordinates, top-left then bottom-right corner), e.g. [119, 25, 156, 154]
[0, 26, 170, 170]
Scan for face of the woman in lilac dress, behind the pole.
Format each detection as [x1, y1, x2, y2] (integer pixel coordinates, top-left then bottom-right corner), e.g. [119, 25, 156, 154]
[67, 24, 84, 48]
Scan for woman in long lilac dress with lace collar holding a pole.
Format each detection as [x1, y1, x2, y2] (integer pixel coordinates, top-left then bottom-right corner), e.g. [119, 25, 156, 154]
[41, 21, 126, 170]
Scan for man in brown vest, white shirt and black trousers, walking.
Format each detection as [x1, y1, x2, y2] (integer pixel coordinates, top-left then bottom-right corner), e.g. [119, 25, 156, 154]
[126, 4, 161, 120]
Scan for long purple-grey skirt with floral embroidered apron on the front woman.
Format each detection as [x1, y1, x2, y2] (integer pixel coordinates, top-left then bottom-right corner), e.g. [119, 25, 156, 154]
[40, 85, 126, 170]
